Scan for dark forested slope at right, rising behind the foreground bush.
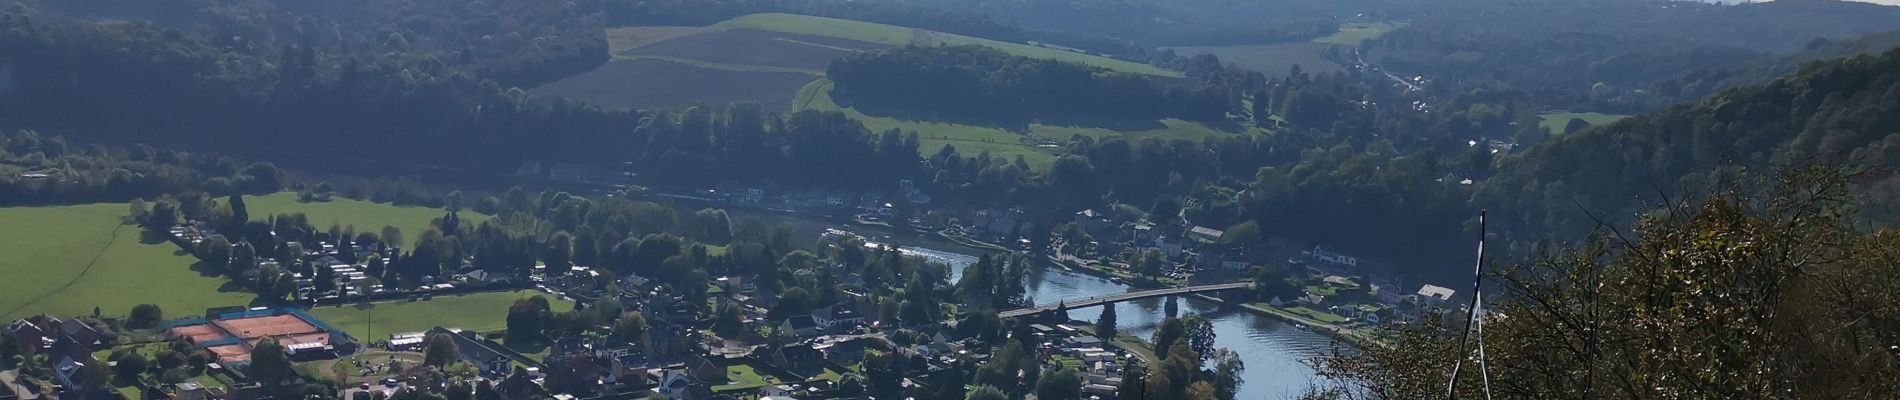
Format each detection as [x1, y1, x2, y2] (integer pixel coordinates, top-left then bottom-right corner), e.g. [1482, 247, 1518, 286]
[1476, 49, 1900, 252]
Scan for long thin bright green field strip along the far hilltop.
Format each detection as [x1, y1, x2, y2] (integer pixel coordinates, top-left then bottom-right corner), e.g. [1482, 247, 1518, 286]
[711, 13, 1182, 78]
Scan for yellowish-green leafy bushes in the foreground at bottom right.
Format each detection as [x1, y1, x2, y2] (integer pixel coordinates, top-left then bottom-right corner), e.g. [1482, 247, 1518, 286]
[1305, 167, 1900, 398]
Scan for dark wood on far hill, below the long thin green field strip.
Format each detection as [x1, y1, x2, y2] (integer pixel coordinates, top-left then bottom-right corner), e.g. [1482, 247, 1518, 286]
[825, 45, 1239, 127]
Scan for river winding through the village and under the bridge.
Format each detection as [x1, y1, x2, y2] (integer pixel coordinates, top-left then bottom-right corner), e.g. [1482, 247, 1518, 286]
[710, 207, 1334, 400]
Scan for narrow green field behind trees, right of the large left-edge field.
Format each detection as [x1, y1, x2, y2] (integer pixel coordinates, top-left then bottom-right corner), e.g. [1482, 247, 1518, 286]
[243, 191, 488, 233]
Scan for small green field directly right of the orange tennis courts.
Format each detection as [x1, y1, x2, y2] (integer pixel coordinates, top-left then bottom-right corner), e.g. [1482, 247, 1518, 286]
[310, 290, 574, 341]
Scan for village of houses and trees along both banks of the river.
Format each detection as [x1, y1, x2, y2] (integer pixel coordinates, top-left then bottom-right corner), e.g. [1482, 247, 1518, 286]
[0, 182, 1459, 400]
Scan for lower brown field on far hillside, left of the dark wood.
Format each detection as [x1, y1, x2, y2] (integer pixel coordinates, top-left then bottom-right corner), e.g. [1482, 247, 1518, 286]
[532, 59, 817, 110]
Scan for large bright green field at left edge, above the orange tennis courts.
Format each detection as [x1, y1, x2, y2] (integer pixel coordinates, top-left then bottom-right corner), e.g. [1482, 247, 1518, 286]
[0, 203, 255, 320]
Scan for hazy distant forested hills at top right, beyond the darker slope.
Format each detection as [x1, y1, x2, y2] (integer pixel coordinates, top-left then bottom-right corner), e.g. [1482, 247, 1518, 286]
[1362, 0, 1900, 114]
